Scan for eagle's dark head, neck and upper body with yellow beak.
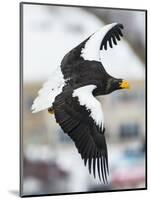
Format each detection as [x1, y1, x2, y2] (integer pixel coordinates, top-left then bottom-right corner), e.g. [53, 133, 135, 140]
[70, 61, 130, 96]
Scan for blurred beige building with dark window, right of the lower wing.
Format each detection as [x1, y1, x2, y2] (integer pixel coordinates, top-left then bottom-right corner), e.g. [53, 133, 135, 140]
[100, 80, 145, 142]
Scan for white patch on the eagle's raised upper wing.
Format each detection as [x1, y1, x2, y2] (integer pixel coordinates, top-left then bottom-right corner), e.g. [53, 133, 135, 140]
[81, 23, 117, 61]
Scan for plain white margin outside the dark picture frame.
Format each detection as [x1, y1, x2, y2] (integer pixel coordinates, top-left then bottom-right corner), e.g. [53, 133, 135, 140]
[0, 0, 151, 200]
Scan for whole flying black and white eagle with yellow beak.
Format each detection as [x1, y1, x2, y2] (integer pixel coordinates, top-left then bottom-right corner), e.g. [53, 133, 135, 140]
[31, 23, 130, 184]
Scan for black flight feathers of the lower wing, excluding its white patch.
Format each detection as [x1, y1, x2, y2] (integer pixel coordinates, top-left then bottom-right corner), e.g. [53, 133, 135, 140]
[53, 89, 108, 183]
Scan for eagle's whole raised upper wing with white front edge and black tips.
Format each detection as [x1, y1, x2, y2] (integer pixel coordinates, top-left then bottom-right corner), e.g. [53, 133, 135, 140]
[61, 23, 124, 66]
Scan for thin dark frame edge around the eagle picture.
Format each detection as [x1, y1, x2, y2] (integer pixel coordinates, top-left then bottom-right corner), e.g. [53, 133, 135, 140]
[19, 2, 148, 197]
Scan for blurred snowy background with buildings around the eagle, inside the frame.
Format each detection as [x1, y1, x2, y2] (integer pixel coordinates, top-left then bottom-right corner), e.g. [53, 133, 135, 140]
[22, 4, 146, 195]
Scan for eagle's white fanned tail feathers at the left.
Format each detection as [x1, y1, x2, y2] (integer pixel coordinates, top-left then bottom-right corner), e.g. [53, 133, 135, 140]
[31, 66, 65, 113]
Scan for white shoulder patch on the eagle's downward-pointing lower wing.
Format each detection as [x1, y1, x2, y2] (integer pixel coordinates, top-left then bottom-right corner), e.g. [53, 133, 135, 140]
[72, 85, 104, 130]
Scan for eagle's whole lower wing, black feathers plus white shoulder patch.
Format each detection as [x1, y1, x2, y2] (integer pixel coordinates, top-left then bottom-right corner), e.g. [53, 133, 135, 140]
[53, 85, 108, 183]
